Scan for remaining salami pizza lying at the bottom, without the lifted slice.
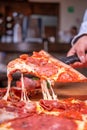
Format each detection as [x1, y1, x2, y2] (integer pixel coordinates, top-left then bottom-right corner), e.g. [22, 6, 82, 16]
[0, 88, 87, 130]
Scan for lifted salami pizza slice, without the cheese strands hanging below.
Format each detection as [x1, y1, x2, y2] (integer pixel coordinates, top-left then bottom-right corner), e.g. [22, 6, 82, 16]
[7, 50, 86, 83]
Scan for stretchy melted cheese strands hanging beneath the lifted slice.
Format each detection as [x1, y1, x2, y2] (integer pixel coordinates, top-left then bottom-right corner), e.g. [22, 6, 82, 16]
[3, 74, 57, 102]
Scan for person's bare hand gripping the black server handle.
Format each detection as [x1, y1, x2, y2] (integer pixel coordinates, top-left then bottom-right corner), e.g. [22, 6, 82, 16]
[67, 35, 87, 63]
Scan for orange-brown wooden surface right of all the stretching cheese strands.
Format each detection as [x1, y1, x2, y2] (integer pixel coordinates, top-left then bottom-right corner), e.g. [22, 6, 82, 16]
[54, 82, 87, 100]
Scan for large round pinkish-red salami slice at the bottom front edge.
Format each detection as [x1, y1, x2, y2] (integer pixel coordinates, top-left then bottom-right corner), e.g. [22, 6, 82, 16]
[11, 114, 77, 130]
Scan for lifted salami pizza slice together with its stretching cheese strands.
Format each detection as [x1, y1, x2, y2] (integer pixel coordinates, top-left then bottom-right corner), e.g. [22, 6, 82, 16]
[4, 50, 86, 101]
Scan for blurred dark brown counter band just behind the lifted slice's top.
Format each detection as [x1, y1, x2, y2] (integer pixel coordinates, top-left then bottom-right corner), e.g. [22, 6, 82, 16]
[0, 43, 71, 53]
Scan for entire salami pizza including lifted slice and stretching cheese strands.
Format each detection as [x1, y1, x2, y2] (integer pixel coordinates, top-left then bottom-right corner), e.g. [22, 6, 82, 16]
[0, 50, 87, 130]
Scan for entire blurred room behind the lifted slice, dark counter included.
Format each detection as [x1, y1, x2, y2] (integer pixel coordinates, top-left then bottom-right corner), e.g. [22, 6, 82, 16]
[0, 0, 87, 87]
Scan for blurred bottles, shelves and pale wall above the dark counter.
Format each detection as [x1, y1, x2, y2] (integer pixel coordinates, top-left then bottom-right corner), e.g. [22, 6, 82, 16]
[0, 0, 87, 43]
